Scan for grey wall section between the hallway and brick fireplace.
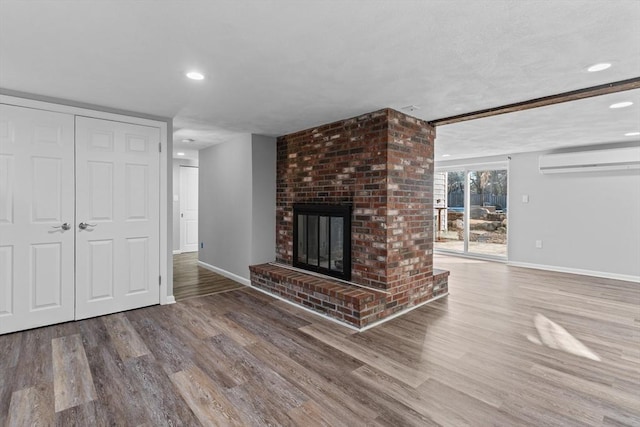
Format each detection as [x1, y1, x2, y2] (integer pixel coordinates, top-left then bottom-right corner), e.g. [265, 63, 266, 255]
[198, 134, 276, 279]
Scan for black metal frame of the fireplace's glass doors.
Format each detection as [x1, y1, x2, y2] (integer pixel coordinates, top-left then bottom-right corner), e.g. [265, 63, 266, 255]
[293, 204, 351, 280]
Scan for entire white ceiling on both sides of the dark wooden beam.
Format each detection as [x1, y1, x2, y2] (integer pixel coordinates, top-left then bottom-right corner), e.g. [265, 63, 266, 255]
[0, 0, 640, 158]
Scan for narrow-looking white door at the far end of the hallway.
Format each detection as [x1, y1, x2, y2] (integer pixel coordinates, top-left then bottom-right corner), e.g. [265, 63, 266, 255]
[180, 166, 198, 252]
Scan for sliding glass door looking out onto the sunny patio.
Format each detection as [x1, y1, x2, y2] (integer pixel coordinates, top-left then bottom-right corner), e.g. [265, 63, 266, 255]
[434, 165, 508, 259]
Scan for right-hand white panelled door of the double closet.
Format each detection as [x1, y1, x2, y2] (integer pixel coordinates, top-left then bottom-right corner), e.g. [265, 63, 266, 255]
[76, 116, 160, 319]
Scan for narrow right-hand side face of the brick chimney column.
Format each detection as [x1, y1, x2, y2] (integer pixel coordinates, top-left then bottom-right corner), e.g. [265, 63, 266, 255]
[386, 110, 435, 302]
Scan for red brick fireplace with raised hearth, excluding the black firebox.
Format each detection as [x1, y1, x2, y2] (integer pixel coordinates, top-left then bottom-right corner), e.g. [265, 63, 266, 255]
[250, 109, 449, 328]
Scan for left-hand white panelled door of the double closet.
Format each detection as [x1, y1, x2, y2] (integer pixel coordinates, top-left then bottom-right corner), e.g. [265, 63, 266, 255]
[0, 104, 74, 334]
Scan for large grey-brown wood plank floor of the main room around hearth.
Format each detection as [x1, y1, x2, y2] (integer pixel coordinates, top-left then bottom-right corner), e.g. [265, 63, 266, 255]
[0, 256, 640, 426]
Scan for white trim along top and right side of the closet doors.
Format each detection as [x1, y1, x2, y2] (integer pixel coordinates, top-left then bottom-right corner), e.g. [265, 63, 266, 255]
[0, 94, 173, 304]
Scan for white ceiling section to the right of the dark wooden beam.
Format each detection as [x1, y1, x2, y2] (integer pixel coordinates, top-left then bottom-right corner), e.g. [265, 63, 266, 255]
[435, 89, 640, 160]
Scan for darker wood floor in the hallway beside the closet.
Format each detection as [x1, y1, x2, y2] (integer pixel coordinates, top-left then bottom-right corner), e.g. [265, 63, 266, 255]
[173, 252, 243, 301]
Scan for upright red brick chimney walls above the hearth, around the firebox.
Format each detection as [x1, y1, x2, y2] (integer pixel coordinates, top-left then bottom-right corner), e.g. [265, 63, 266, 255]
[276, 109, 435, 292]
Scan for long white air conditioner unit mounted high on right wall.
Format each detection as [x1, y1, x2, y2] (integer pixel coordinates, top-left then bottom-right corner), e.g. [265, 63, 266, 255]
[538, 147, 640, 174]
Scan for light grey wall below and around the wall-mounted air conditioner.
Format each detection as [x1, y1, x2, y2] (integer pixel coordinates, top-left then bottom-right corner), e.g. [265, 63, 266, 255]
[436, 142, 640, 280]
